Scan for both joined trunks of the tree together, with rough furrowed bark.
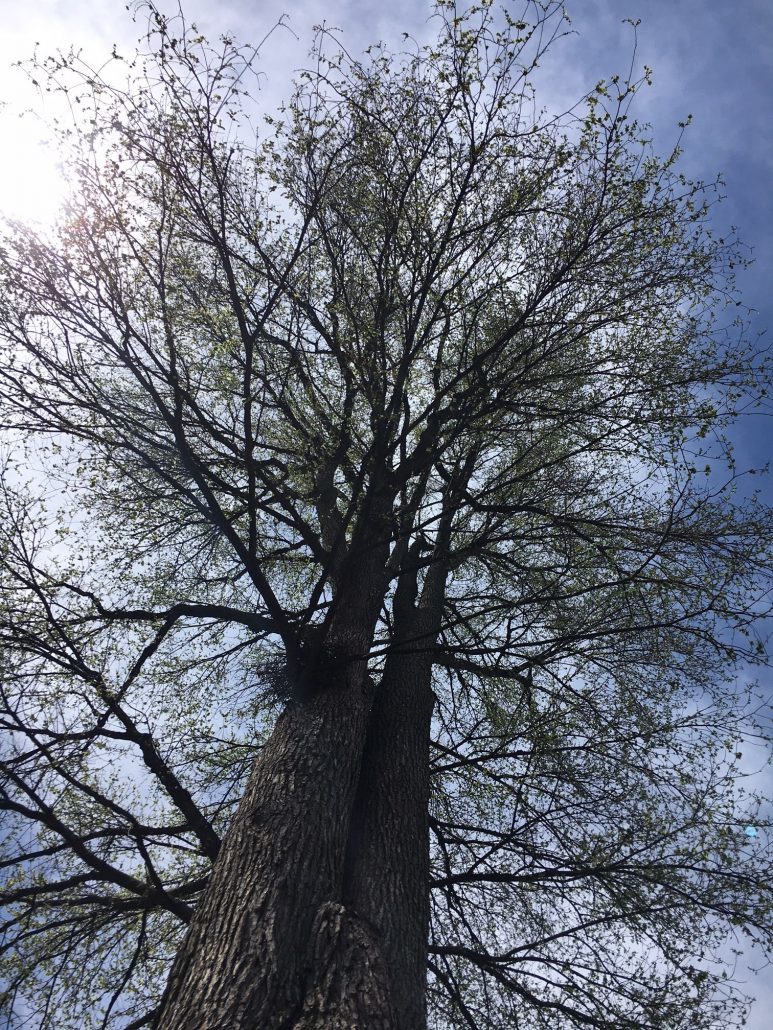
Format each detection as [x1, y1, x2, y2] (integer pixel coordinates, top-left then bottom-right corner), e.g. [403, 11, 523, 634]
[156, 506, 439, 1030]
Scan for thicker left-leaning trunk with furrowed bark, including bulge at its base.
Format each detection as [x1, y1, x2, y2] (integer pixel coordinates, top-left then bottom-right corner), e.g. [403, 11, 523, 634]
[156, 516, 393, 1030]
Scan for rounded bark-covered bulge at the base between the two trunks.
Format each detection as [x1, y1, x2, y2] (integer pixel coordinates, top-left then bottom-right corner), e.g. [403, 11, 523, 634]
[292, 901, 397, 1030]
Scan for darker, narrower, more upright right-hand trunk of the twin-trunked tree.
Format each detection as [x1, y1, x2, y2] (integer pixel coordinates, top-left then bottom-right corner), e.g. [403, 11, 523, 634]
[344, 569, 444, 1030]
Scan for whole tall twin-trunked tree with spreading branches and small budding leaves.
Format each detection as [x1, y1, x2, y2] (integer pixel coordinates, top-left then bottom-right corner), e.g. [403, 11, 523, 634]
[0, 0, 771, 1030]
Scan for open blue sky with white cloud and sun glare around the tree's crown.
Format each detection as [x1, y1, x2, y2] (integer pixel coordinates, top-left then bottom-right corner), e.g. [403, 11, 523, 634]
[0, 0, 773, 1030]
